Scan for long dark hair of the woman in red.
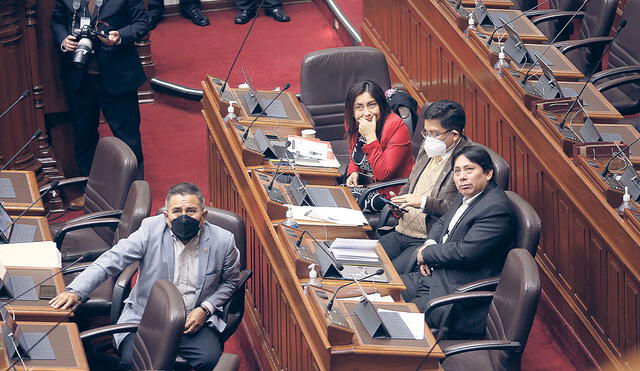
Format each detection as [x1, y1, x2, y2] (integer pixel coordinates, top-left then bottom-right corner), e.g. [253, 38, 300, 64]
[344, 80, 391, 146]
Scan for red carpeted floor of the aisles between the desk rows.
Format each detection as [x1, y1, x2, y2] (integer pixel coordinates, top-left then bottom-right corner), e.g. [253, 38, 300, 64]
[95, 0, 573, 371]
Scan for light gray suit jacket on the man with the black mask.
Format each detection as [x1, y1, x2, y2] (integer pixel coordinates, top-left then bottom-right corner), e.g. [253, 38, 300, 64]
[68, 215, 240, 345]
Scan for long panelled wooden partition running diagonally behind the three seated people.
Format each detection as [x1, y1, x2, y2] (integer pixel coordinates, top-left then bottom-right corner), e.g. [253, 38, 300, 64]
[362, 0, 640, 368]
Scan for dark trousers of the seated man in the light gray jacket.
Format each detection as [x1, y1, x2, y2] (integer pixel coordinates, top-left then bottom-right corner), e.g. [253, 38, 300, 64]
[118, 327, 222, 371]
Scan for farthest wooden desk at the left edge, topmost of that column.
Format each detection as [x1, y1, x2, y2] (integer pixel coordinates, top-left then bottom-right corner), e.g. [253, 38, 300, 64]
[0, 170, 46, 216]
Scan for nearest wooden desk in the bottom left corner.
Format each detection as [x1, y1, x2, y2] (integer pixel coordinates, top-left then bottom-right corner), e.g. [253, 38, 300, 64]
[0, 322, 89, 371]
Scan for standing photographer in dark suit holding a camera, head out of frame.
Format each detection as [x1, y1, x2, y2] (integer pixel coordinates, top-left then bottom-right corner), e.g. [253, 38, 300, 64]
[51, 0, 149, 178]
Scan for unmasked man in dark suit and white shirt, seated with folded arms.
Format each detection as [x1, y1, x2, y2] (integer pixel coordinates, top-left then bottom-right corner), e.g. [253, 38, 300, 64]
[401, 146, 516, 327]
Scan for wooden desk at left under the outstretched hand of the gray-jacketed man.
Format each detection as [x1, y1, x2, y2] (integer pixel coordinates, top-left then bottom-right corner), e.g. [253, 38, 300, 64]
[0, 267, 73, 321]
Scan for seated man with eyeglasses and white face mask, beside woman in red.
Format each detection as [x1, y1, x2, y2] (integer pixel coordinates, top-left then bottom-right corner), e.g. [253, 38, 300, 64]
[379, 100, 471, 274]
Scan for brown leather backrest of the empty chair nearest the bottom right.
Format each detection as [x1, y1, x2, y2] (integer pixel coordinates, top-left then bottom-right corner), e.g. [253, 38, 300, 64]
[486, 249, 540, 370]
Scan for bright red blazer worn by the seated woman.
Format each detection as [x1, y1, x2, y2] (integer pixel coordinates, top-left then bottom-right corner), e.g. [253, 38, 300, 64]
[347, 112, 413, 197]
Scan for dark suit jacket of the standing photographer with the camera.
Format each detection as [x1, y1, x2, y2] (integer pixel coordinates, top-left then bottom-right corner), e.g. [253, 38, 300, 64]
[51, 0, 149, 94]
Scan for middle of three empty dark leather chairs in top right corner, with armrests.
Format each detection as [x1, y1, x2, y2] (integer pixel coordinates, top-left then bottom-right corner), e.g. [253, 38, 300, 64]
[544, 0, 618, 75]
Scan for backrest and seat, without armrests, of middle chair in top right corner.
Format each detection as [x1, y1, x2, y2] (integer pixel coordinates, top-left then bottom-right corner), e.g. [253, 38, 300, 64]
[567, 0, 618, 75]
